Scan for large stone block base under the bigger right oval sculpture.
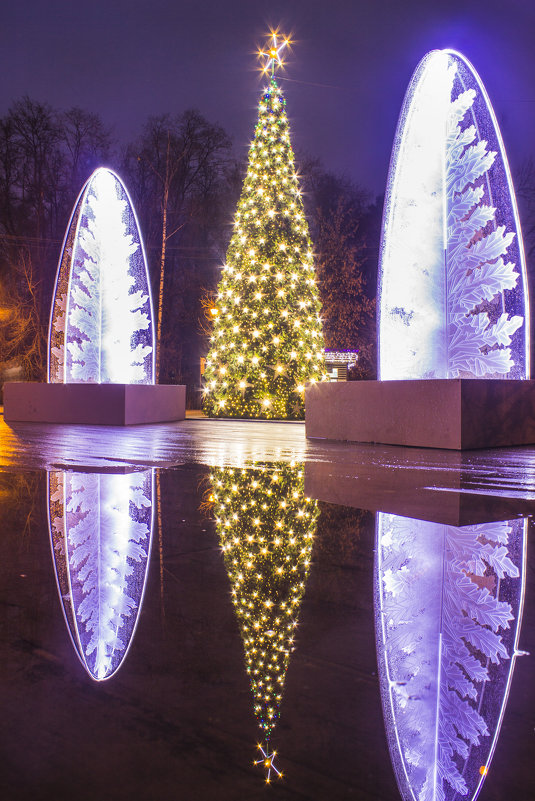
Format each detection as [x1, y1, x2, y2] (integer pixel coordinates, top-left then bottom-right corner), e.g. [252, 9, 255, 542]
[305, 378, 535, 450]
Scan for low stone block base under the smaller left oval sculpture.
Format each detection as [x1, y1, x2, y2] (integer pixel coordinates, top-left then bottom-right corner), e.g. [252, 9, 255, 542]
[4, 382, 186, 426]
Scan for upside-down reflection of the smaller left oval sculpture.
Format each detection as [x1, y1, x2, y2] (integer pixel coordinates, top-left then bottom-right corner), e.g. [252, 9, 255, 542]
[48, 470, 153, 681]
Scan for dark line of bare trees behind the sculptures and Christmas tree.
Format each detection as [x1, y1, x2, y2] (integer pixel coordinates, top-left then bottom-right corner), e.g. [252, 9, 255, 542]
[14, 97, 535, 406]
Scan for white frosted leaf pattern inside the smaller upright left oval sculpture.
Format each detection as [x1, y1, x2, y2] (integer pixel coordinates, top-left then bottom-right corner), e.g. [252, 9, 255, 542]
[66, 170, 152, 383]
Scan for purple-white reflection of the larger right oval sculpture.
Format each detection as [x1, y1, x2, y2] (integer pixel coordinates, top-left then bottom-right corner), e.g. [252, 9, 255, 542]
[374, 513, 526, 801]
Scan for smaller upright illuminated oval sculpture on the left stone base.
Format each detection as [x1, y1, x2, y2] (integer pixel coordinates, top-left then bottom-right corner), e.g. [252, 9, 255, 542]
[48, 168, 154, 384]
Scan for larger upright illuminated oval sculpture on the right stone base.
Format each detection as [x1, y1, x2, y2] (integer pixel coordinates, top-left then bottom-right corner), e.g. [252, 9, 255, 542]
[379, 50, 529, 380]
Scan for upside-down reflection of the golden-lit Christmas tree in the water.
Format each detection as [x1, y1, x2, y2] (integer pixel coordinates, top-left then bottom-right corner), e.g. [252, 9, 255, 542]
[211, 464, 318, 781]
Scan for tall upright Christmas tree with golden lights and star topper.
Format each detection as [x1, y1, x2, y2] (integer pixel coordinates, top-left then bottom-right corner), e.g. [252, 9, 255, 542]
[204, 34, 326, 419]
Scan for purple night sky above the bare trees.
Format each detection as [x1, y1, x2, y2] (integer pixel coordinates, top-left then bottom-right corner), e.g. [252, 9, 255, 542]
[0, 0, 535, 193]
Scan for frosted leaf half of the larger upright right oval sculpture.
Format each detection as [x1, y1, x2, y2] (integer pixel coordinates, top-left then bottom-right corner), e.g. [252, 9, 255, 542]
[446, 75, 524, 378]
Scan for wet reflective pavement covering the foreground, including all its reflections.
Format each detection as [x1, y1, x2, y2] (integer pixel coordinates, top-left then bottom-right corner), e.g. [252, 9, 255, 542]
[0, 412, 535, 801]
